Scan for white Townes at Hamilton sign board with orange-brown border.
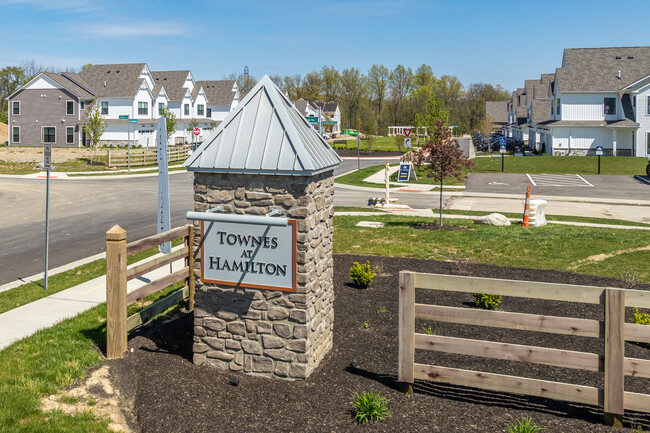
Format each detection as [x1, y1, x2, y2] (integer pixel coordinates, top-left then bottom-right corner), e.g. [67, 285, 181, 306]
[201, 220, 297, 292]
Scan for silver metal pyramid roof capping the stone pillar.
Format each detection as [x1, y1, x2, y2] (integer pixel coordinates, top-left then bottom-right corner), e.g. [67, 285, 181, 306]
[185, 75, 341, 176]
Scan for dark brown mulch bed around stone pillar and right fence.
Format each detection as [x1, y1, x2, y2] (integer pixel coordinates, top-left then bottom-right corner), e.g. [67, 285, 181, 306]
[109, 255, 650, 432]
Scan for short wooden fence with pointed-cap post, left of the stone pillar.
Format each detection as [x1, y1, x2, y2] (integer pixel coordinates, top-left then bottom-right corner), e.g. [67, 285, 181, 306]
[106, 225, 194, 359]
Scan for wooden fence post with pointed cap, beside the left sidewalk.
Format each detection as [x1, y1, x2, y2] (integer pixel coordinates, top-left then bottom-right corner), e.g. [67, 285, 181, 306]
[106, 225, 126, 359]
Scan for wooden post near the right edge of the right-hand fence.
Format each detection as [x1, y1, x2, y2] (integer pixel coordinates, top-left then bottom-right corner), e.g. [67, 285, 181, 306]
[604, 289, 625, 427]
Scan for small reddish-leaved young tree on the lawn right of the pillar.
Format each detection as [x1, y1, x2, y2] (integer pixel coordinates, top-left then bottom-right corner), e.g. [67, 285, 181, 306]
[414, 120, 472, 226]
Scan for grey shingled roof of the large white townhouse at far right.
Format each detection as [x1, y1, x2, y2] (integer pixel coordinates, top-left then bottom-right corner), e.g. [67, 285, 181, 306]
[556, 47, 650, 92]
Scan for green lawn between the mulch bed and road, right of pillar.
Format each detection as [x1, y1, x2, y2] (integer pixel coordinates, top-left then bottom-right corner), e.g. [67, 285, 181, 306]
[334, 215, 650, 282]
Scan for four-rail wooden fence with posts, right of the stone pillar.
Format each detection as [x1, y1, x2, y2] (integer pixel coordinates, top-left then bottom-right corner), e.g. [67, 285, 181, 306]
[398, 271, 650, 426]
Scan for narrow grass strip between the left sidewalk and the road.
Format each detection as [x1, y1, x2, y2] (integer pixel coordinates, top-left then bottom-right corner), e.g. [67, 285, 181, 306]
[0, 239, 182, 314]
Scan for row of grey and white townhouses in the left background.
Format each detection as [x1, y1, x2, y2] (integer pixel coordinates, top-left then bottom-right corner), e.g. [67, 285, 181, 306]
[8, 63, 239, 147]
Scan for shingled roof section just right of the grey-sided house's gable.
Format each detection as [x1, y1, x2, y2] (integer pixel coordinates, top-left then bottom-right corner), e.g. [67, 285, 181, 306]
[75, 63, 146, 98]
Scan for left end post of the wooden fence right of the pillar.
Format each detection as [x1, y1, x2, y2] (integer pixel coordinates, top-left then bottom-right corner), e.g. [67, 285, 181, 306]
[397, 271, 415, 394]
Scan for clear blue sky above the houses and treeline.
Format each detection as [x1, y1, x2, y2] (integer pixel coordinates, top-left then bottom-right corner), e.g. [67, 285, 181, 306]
[0, 0, 650, 90]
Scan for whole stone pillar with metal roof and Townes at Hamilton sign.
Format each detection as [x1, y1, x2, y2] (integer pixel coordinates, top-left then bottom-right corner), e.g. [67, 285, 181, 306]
[185, 76, 340, 379]
